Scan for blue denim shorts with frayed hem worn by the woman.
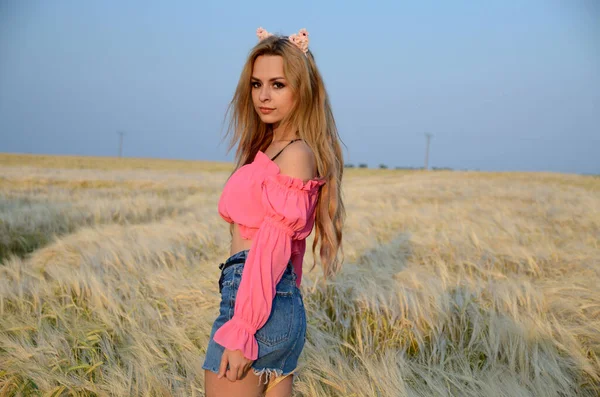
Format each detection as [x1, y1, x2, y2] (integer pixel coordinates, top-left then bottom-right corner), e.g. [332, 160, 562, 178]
[202, 250, 306, 383]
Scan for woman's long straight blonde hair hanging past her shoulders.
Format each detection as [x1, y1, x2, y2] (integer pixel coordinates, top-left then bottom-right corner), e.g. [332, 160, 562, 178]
[226, 35, 346, 277]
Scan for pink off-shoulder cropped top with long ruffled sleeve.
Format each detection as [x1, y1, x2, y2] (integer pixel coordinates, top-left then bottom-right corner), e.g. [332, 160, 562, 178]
[214, 151, 325, 360]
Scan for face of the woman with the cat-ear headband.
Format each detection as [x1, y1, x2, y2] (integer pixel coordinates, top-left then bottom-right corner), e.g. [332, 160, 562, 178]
[251, 55, 294, 124]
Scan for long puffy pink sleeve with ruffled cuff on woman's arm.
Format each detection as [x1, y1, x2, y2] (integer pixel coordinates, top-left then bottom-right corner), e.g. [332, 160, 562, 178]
[214, 174, 324, 360]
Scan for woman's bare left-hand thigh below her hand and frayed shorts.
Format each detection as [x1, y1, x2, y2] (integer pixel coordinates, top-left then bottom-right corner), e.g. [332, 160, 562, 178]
[204, 369, 264, 397]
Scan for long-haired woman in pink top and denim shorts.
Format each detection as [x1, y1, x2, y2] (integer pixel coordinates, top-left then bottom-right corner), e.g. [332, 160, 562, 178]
[203, 28, 345, 397]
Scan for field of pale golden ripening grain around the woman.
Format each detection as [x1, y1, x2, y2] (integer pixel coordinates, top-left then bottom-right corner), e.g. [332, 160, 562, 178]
[0, 154, 600, 397]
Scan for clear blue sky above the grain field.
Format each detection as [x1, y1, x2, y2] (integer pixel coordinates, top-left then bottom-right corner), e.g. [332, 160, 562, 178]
[0, 0, 600, 173]
